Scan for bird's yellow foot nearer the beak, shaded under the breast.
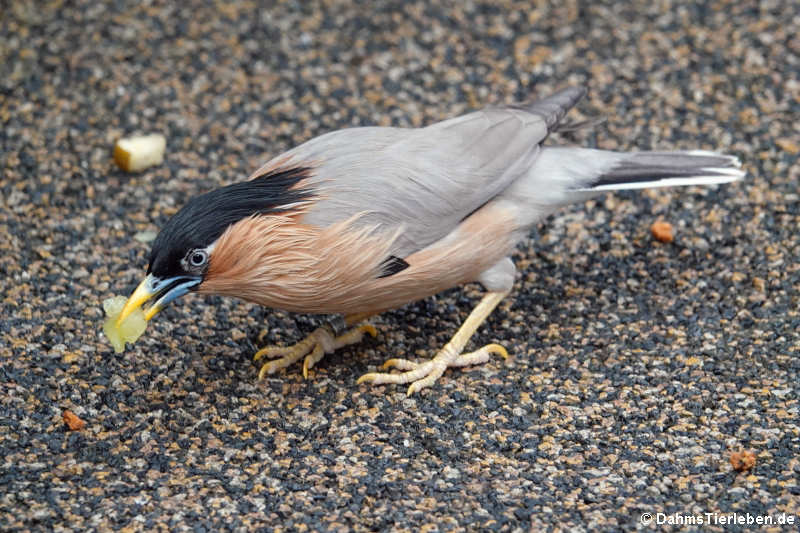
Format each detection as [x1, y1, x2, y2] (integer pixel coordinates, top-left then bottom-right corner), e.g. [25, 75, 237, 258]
[253, 324, 378, 379]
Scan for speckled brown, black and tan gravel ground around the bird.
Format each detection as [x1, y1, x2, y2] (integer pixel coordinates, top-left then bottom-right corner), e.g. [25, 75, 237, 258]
[0, 0, 800, 531]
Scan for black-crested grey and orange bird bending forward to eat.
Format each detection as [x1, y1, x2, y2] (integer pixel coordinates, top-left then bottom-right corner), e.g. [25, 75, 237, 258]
[117, 86, 745, 395]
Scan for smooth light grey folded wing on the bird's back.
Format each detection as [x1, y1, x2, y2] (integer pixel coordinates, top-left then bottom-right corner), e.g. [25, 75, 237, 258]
[268, 87, 584, 258]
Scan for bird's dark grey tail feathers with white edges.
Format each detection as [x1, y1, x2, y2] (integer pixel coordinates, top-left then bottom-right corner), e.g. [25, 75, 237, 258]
[582, 150, 745, 191]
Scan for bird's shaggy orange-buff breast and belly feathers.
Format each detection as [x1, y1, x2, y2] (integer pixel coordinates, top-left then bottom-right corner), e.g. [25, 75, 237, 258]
[198, 204, 514, 314]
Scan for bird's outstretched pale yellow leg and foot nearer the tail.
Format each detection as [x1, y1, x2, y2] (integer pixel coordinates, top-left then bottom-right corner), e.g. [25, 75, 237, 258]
[358, 291, 508, 396]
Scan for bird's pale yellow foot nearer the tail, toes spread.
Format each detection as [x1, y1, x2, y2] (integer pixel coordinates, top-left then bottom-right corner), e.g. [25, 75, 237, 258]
[358, 344, 508, 396]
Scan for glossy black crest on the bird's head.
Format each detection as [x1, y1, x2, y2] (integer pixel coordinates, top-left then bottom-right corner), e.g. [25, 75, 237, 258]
[147, 167, 311, 278]
